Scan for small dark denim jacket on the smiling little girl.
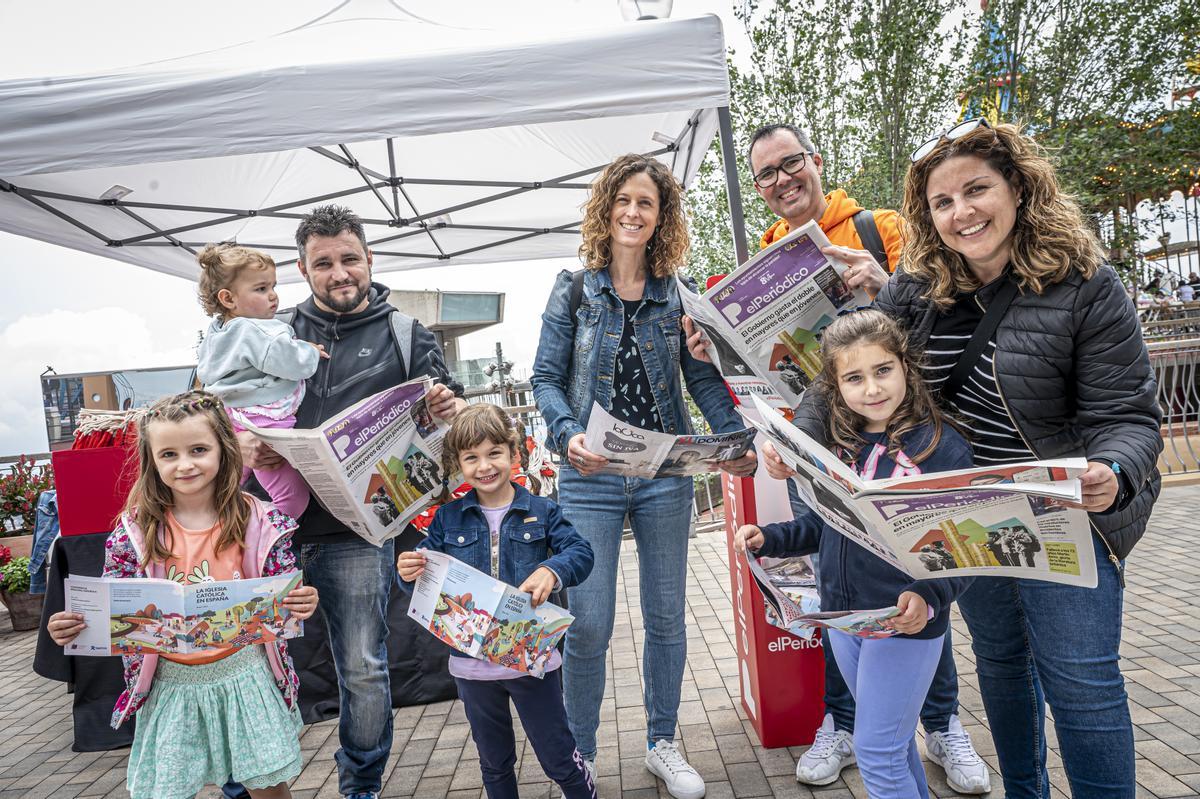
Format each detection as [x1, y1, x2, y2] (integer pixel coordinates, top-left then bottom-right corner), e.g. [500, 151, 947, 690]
[416, 483, 593, 588]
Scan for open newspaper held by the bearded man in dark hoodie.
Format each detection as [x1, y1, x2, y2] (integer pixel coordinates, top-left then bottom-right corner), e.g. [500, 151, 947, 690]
[247, 377, 448, 546]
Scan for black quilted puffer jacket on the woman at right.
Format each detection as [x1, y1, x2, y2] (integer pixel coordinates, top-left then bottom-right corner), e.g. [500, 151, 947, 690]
[796, 266, 1163, 558]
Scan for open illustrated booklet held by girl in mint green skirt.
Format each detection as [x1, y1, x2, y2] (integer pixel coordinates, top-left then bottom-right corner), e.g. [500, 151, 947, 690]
[64, 571, 304, 656]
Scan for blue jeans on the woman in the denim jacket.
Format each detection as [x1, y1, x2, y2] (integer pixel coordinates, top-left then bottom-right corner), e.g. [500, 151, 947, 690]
[558, 464, 692, 759]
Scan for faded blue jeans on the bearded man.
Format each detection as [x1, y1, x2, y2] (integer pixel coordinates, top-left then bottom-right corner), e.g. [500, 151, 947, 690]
[300, 541, 396, 794]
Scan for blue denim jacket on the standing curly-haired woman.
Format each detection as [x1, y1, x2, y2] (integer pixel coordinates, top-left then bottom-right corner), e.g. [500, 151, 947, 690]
[530, 269, 745, 453]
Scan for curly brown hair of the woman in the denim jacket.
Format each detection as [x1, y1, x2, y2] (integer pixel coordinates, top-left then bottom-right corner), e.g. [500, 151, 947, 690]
[580, 152, 689, 277]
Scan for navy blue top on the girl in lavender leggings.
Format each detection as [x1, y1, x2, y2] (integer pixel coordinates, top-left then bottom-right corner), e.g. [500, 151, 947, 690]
[757, 426, 972, 638]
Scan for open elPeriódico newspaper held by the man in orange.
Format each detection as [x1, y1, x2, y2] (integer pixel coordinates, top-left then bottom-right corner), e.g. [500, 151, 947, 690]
[679, 222, 871, 414]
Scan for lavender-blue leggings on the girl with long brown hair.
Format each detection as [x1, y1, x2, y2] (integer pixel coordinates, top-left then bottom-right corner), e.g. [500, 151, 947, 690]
[829, 631, 942, 799]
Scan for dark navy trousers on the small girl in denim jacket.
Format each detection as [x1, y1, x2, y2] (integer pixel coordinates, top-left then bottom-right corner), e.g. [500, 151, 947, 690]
[455, 669, 596, 799]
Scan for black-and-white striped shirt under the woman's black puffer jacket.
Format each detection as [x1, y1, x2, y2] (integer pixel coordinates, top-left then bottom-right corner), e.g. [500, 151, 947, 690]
[924, 294, 1034, 465]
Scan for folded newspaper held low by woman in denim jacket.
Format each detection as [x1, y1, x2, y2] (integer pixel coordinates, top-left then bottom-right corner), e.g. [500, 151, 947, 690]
[583, 403, 755, 477]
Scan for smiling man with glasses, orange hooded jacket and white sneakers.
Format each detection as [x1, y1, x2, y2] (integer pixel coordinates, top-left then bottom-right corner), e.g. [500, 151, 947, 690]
[750, 124, 991, 794]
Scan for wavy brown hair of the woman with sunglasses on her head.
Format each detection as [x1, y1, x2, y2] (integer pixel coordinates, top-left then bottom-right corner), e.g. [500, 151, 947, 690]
[900, 125, 1104, 308]
